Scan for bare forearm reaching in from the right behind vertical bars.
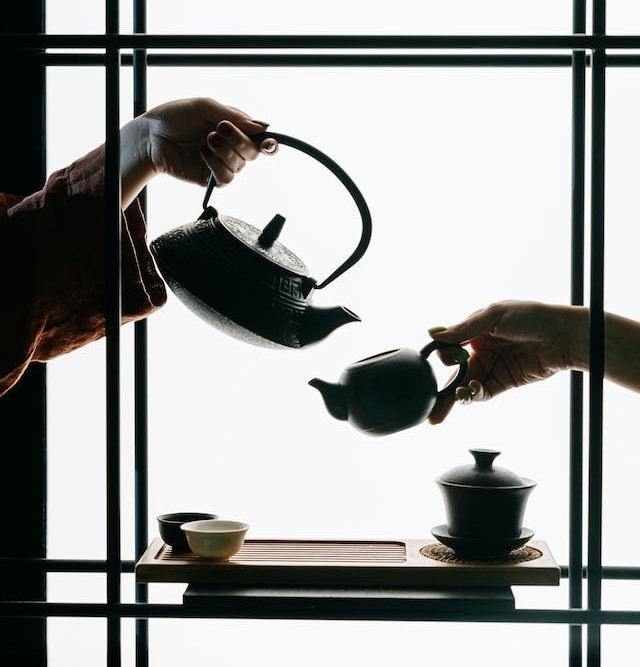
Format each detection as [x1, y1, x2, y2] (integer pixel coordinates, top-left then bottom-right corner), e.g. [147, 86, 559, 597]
[566, 306, 640, 392]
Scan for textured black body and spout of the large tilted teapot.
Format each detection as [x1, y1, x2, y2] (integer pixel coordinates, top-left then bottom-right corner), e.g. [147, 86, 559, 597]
[151, 214, 360, 348]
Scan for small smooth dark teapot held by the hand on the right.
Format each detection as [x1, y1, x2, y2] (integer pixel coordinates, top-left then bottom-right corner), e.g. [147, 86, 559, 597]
[309, 341, 467, 435]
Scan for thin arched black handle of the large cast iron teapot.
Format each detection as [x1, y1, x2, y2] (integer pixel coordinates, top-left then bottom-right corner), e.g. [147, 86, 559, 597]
[202, 132, 371, 289]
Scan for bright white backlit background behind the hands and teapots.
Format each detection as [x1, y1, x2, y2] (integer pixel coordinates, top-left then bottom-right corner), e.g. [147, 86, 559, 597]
[42, 0, 640, 667]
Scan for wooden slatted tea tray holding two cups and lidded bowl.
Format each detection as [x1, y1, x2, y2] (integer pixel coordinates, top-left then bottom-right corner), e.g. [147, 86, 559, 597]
[135, 538, 560, 587]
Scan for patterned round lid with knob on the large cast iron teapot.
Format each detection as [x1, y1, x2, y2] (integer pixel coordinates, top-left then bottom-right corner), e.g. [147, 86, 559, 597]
[218, 209, 309, 276]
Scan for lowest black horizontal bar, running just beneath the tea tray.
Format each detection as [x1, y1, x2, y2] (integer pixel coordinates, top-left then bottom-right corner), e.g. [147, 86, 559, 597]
[0, 604, 640, 625]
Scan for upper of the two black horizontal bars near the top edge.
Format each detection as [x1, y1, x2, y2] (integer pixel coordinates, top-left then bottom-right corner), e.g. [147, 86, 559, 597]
[0, 34, 640, 51]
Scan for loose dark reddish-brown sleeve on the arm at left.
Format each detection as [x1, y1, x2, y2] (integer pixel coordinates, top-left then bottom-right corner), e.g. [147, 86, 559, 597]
[0, 147, 167, 395]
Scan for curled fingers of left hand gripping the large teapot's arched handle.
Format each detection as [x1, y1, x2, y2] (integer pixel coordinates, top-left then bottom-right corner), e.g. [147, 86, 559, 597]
[202, 120, 278, 186]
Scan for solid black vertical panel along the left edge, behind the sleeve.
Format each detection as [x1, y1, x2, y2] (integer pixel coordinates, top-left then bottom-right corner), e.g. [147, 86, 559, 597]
[0, 0, 47, 666]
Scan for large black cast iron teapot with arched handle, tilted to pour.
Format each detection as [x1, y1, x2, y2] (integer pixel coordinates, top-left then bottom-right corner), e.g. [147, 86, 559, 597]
[151, 132, 371, 348]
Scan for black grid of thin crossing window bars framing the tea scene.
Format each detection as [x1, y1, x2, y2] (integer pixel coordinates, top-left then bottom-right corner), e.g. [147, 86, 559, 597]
[0, 3, 640, 666]
